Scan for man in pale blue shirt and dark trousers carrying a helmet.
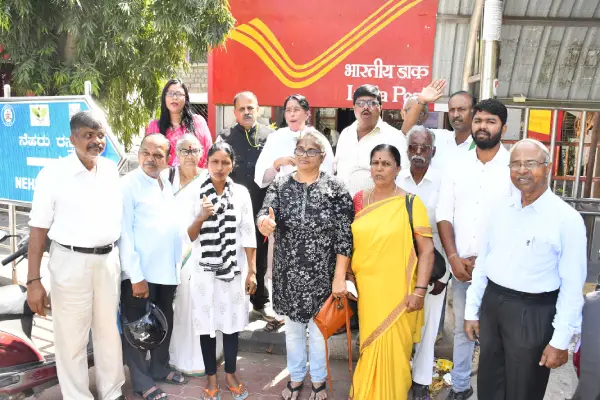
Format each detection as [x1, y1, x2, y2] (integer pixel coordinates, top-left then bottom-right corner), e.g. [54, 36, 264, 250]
[119, 133, 187, 399]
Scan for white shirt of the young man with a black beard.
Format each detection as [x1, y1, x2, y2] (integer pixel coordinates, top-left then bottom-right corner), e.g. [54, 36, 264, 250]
[435, 145, 513, 258]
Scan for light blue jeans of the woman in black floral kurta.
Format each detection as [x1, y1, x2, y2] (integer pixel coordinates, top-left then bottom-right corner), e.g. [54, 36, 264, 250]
[285, 317, 327, 382]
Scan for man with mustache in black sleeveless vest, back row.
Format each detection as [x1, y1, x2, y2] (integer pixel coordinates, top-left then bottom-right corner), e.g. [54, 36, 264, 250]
[217, 92, 275, 322]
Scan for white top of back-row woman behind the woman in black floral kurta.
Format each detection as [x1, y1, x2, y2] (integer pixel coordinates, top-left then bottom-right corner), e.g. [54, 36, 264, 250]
[254, 128, 334, 188]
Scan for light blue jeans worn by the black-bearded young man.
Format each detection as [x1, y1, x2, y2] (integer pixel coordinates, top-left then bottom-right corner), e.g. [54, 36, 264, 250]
[451, 278, 475, 392]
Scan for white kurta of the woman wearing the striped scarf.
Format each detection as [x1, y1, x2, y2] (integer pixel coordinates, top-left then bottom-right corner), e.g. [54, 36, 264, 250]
[188, 184, 256, 337]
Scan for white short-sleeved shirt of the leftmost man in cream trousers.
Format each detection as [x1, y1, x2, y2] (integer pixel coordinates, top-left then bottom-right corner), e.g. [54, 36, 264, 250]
[29, 152, 123, 248]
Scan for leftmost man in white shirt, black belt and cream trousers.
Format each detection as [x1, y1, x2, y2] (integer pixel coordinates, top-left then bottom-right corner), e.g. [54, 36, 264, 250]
[27, 111, 125, 400]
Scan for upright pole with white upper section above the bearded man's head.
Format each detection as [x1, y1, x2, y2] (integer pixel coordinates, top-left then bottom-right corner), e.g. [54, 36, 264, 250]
[479, 0, 502, 100]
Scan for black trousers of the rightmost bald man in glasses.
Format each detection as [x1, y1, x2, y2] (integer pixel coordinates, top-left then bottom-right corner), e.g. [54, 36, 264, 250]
[477, 281, 558, 400]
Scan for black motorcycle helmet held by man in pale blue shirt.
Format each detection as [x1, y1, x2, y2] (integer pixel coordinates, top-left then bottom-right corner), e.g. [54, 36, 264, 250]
[122, 301, 169, 350]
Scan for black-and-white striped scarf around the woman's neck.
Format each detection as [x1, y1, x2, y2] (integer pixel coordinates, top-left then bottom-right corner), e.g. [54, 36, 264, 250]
[199, 177, 241, 282]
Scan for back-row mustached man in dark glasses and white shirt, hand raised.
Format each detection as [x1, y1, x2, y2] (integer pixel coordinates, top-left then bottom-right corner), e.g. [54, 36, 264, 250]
[335, 80, 446, 196]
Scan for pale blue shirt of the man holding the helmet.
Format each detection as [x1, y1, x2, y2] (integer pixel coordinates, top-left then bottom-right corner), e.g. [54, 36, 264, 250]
[119, 167, 182, 285]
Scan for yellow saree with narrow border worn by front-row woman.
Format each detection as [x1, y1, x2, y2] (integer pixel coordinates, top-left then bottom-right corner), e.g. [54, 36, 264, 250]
[350, 196, 431, 400]
